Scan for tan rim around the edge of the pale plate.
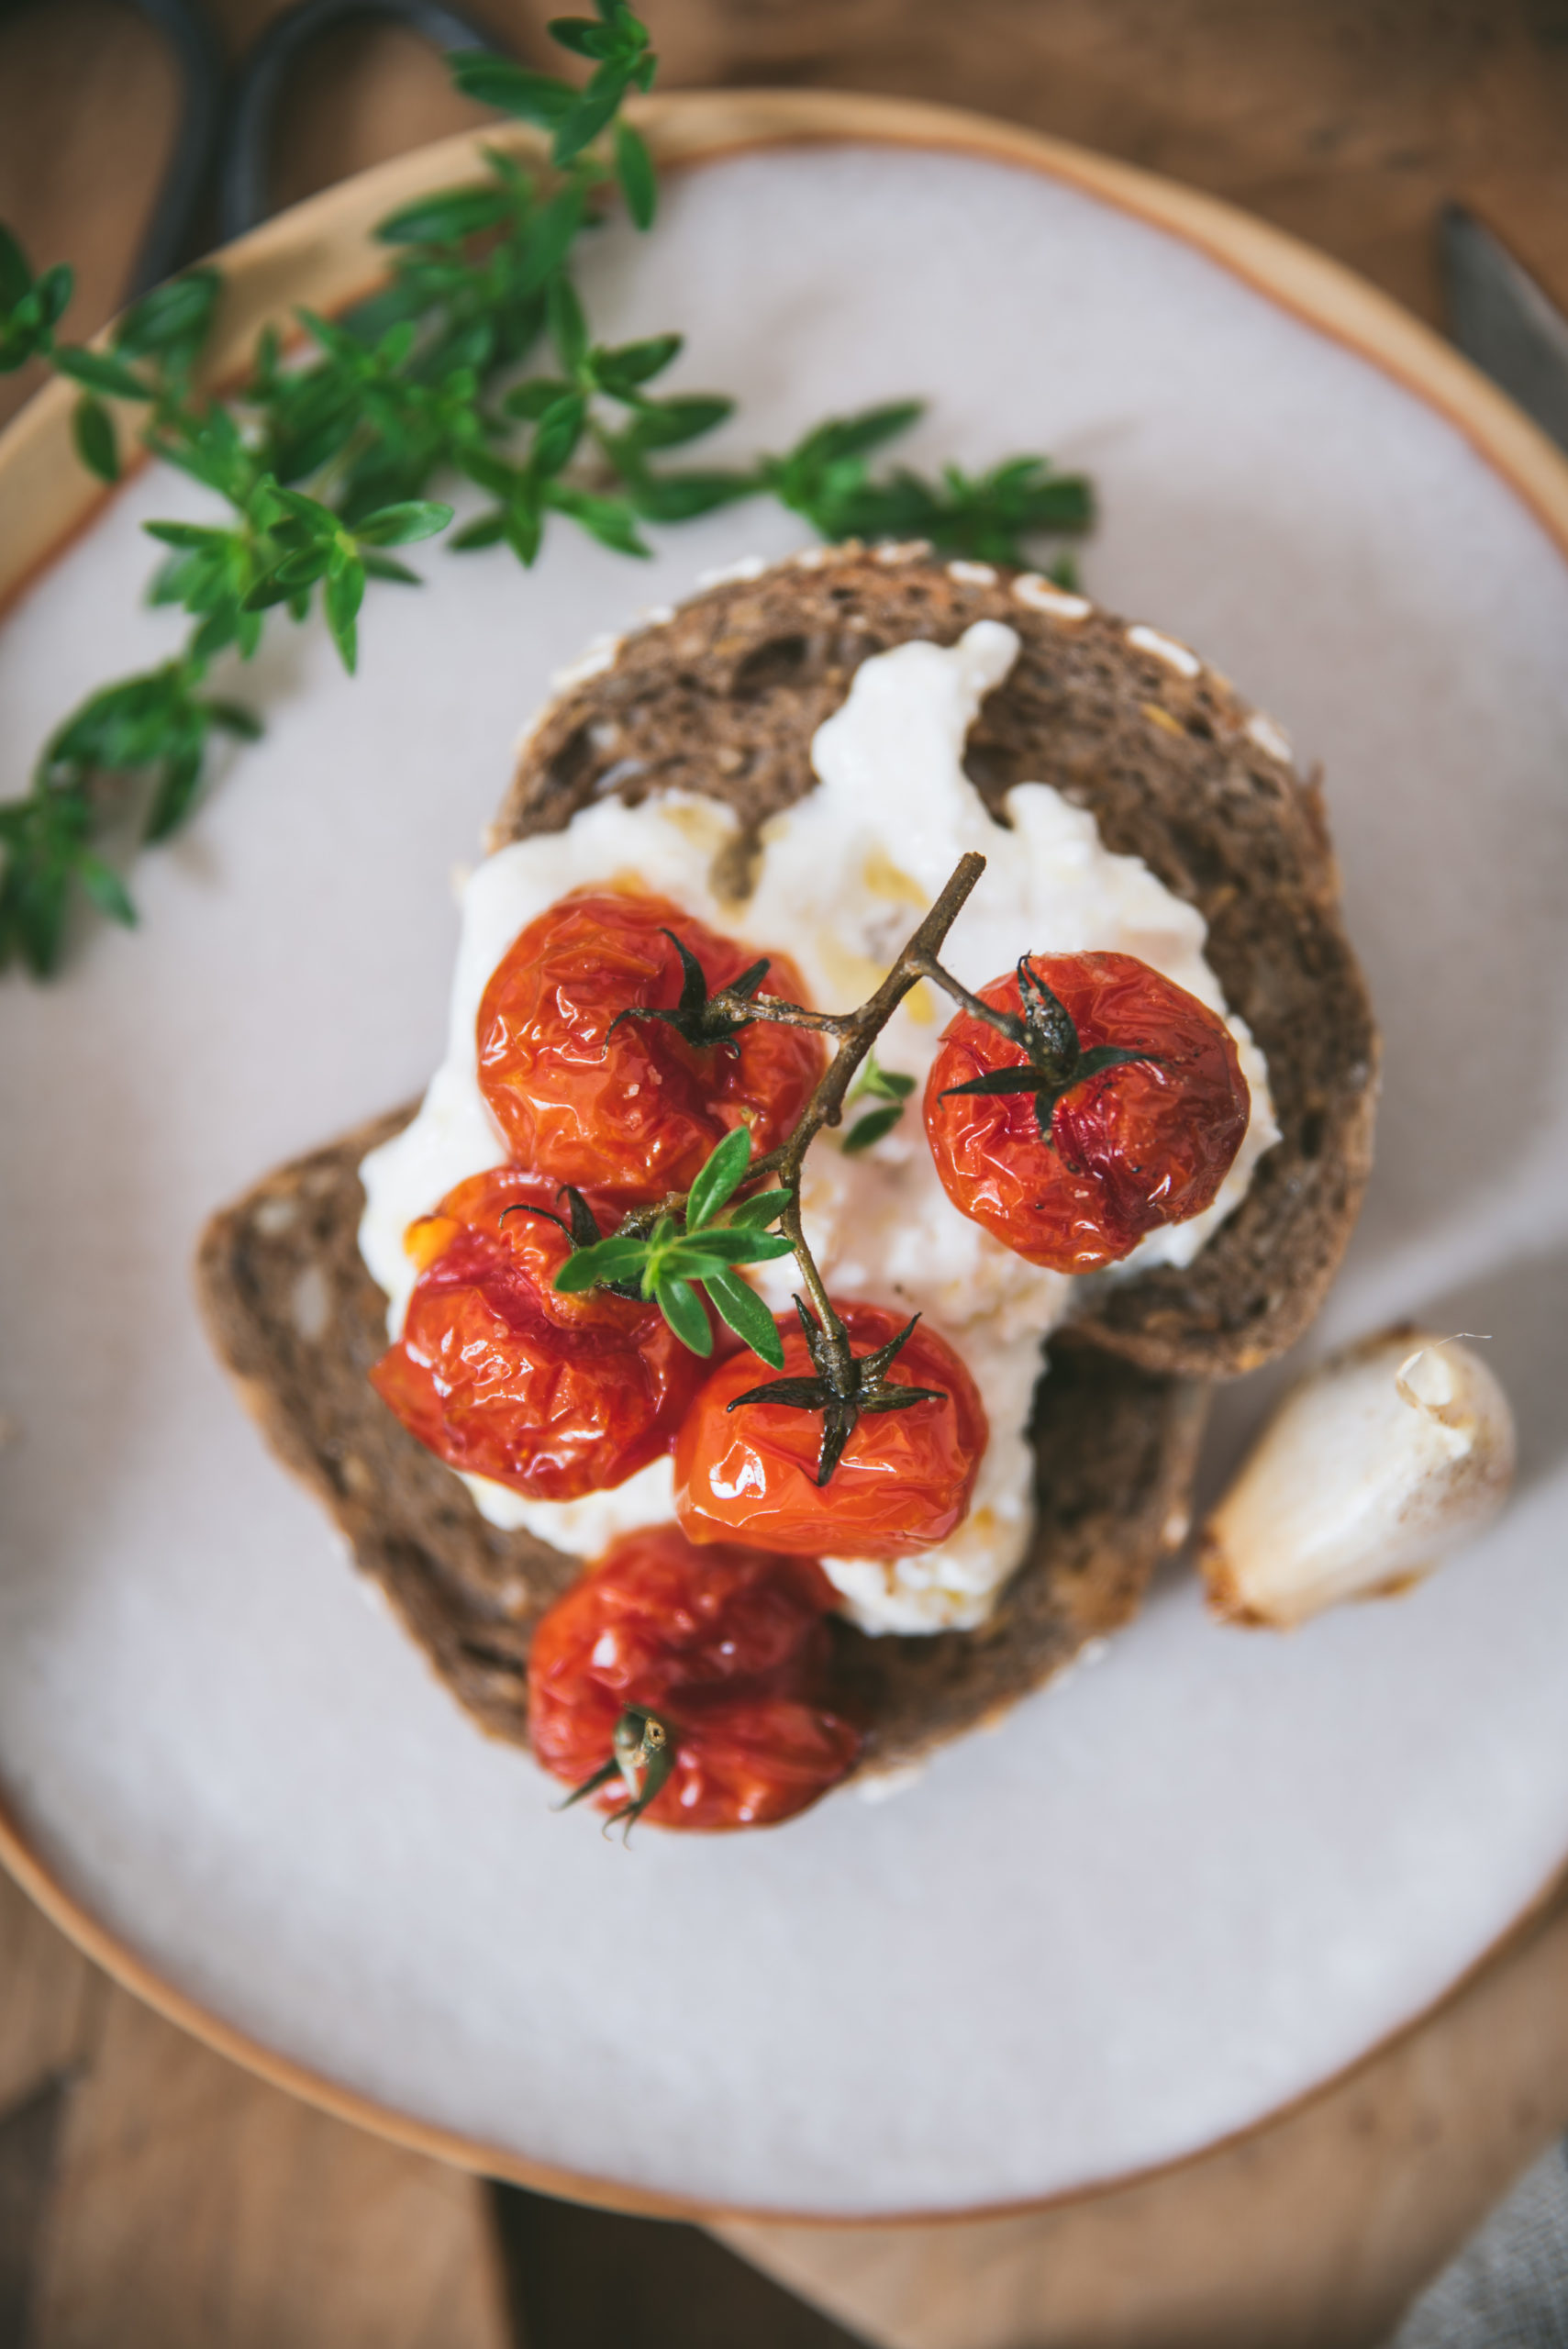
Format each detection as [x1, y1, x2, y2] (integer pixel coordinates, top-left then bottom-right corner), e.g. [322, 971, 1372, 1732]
[0, 89, 1568, 2227]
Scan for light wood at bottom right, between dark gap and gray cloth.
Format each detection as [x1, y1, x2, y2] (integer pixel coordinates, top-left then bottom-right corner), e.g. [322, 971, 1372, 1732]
[714, 1903, 1568, 2349]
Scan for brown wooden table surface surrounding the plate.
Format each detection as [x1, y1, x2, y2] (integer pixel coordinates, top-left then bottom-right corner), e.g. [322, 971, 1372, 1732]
[0, 0, 1568, 2349]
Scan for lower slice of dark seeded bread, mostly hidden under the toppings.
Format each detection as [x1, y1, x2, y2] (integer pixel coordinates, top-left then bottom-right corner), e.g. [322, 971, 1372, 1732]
[195, 1111, 1207, 1774]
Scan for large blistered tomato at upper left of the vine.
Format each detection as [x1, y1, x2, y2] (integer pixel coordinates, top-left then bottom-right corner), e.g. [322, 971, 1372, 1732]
[476, 890, 827, 1205]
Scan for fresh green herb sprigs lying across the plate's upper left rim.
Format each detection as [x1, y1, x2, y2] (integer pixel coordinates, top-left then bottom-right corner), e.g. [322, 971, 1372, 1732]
[0, 0, 1092, 977]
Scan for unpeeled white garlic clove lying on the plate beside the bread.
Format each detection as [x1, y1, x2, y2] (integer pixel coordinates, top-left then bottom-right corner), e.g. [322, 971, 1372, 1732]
[1199, 1327, 1514, 1631]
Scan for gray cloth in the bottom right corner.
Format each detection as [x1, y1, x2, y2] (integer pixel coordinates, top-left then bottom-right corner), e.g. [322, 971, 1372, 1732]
[1387, 2143, 1568, 2349]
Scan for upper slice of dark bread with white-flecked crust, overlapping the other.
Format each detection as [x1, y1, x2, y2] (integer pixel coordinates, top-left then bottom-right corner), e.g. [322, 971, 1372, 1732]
[491, 547, 1378, 1379]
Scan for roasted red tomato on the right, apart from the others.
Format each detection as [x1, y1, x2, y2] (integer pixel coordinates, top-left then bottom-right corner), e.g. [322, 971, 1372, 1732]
[925, 953, 1251, 1274]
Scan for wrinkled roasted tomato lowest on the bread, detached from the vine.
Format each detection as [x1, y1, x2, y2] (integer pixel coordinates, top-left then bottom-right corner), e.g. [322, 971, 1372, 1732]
[528, 1524, 862, 1832]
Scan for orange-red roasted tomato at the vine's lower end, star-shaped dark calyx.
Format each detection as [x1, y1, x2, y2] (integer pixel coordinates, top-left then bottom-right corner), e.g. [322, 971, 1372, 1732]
[676, 1304, 988, 1557]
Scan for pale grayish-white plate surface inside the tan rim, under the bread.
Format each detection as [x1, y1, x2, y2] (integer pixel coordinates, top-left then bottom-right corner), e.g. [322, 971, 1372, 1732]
[0, 114, 1568, 2215]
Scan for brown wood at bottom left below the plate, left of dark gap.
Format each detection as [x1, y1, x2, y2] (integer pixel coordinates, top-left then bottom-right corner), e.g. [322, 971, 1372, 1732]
[0, 1876, 512, 2349]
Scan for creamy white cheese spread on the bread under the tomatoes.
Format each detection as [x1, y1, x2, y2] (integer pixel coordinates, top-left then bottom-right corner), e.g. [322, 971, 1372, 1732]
[359, 620, 1279, 1632]
